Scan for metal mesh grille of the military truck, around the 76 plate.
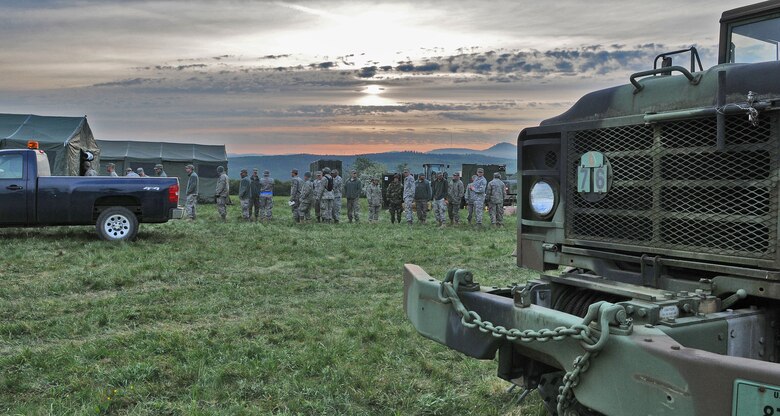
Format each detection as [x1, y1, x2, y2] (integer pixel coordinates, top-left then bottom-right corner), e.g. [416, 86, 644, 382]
[566, 113, 778, 259]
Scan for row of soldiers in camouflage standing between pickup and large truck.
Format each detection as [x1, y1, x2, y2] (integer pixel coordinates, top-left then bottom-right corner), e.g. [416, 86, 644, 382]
[185, 165, 506, 227]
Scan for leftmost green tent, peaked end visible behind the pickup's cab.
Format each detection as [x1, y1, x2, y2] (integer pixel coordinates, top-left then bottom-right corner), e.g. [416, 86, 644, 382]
[0, 114, 100, 175]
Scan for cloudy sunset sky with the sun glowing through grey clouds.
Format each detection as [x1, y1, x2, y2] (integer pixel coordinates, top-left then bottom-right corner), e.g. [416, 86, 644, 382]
[0, 0, 753, 154]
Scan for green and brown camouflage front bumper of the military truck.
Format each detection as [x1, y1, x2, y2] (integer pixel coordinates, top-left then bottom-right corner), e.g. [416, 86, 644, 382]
[404, 264, 780, 416]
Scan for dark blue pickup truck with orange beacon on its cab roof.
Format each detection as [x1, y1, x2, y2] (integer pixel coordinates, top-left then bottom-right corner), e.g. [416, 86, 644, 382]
[0, 142, 183, 241]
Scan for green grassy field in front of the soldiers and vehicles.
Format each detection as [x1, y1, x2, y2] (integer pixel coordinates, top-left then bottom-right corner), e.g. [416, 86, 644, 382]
[0, 199, 543, 415]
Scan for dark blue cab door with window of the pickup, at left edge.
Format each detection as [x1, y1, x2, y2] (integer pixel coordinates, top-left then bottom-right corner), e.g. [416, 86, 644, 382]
[0, 153, 30, 225]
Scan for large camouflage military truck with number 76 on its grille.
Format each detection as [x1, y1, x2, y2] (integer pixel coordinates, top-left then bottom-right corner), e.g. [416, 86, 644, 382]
[404, 0, 780, 416]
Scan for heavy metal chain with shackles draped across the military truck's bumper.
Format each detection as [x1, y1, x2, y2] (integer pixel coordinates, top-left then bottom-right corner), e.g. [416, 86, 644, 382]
[439, 269, 622, 416]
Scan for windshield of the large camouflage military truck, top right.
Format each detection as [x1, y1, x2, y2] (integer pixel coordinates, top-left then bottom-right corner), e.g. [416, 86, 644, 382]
[729, 16, 780, 63]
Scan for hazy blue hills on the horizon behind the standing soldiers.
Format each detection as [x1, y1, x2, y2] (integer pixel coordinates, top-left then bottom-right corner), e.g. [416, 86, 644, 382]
[228, 152, 517, 180]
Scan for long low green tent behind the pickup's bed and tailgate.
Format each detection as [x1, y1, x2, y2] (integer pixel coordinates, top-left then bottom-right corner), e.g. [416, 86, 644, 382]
[97, 140, 228, 201]
